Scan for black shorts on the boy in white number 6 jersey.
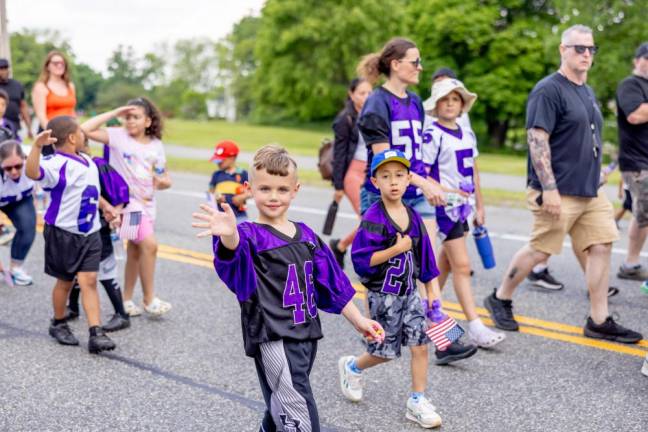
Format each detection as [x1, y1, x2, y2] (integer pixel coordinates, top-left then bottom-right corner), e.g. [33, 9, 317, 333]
[43, 224, 101, 281]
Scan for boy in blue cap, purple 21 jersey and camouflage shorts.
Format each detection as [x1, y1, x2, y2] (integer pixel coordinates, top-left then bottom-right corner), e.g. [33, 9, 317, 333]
[338, 149, 441, 428]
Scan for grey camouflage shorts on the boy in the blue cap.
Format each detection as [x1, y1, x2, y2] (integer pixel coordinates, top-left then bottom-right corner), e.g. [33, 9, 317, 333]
[367, 289, 430, 359]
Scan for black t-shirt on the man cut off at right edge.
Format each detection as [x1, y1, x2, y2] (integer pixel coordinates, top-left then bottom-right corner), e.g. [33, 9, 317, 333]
[616, 75, 648, 171]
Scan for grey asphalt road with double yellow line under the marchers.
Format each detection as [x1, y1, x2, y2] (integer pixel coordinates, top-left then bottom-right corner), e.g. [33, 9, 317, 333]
[0, 170, 648, 432]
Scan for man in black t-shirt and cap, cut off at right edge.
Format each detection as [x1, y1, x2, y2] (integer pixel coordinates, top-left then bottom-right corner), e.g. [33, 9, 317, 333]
[616, 42, 648, 280]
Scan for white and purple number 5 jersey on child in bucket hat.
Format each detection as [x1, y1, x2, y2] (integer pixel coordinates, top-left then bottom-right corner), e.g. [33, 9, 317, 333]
[423, 123, 479, 189]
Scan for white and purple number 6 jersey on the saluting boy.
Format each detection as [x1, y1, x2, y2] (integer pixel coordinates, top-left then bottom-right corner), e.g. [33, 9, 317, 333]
[38, 152, 101, 236]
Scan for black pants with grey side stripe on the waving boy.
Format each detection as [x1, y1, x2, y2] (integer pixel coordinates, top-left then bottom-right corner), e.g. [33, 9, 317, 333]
[254, 340, 320, 432]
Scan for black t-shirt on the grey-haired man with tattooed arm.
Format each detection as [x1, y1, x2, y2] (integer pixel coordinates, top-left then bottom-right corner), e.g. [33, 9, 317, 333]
[526, 72, 603, 197]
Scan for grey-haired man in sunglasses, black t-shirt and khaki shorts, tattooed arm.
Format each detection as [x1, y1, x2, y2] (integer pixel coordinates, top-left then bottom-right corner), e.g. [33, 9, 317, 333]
[484, 25, 642, 343]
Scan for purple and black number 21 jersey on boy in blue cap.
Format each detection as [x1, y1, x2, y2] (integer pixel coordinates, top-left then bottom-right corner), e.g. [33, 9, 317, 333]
[351, 201, 439, 295]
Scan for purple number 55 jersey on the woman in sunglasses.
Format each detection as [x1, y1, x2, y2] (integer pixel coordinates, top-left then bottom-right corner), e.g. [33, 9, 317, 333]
[358, 87, 427, 198]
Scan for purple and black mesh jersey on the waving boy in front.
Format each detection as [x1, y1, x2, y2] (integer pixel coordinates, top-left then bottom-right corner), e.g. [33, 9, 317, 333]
[213, 222, 355, 356]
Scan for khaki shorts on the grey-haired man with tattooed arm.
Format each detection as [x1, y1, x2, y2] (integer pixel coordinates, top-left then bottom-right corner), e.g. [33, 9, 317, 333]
[527, 188, 619, 255]
